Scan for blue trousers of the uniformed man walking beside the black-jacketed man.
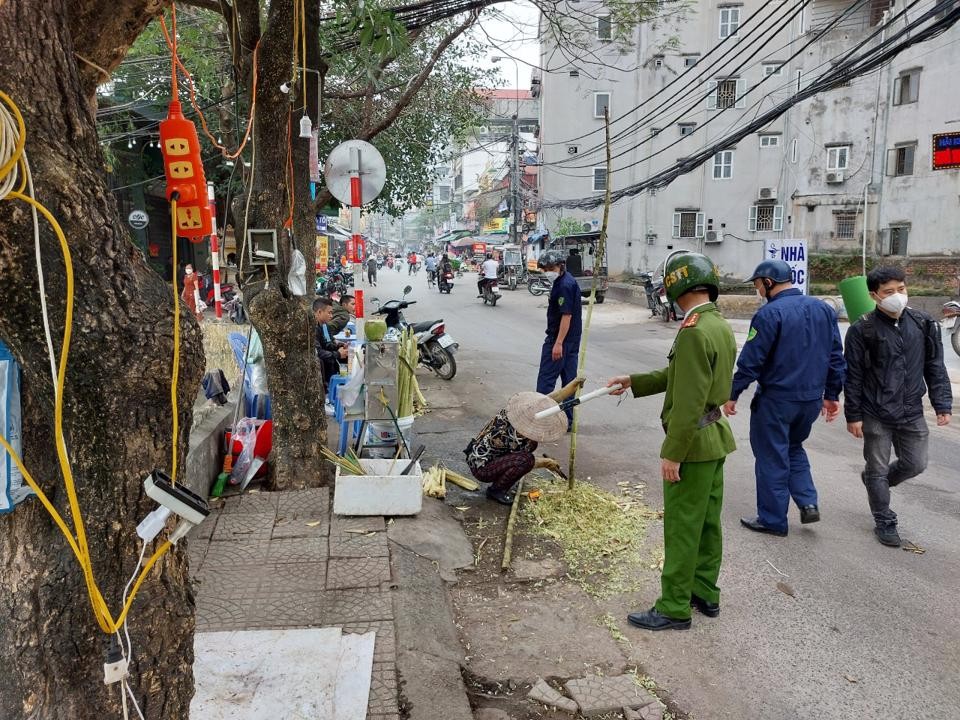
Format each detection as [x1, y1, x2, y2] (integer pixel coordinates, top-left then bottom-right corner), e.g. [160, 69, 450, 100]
[750, 395, 823, 530]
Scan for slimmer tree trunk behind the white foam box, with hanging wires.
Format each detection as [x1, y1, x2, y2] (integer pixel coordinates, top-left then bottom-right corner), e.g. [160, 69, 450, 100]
[235, 0, 331, 490]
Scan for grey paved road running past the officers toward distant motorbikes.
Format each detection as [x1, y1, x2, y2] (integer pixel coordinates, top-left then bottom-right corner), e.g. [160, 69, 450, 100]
[362, 271, 960, 720]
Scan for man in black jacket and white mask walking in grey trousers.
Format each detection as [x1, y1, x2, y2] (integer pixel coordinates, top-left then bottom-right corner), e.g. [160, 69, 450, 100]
[843, 268, 953, 547]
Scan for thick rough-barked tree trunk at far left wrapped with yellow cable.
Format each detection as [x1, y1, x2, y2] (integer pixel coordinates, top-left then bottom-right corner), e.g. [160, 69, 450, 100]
[0, 0, 203, 720]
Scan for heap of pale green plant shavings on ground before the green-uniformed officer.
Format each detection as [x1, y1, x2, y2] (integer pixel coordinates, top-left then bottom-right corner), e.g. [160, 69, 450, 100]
[521, 482, 660, 599]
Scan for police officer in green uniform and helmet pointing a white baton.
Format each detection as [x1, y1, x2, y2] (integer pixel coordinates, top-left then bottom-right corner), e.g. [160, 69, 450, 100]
[608, 253, 737, 630]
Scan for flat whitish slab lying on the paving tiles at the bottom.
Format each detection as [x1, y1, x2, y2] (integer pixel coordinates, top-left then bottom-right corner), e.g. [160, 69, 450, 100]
[190, 628, 342, 720]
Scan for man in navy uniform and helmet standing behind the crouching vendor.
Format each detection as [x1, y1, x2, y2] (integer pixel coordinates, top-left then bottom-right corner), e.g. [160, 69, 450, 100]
[537, 250, 583, 429]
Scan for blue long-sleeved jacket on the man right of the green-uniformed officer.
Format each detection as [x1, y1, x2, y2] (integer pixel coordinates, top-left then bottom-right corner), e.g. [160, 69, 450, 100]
[730, 288, 847, 402]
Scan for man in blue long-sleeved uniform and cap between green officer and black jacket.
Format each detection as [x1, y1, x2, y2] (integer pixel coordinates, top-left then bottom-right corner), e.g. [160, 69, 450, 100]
[723, 260, 847, 536]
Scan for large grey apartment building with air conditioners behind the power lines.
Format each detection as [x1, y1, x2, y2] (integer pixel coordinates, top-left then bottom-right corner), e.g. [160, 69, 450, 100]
[538, 0, 960, 276]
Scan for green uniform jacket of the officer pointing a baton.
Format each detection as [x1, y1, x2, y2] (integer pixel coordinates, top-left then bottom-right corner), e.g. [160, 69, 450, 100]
[630, 303, 737, 462]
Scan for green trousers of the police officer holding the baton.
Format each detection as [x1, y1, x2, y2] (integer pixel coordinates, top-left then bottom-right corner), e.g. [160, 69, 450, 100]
[655, 458, 726, 620]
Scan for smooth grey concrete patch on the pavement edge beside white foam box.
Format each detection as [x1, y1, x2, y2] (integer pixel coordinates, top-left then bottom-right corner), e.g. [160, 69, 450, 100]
[387, 498, 473, 581]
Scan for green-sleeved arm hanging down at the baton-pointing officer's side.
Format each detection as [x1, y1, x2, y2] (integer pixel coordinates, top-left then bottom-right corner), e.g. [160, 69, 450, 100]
[660, 329, 713, 462]
